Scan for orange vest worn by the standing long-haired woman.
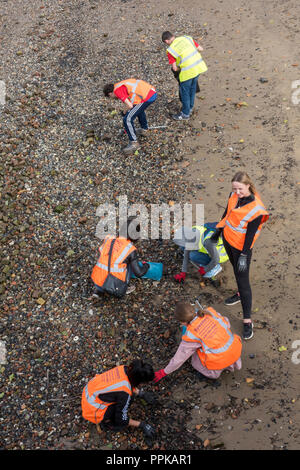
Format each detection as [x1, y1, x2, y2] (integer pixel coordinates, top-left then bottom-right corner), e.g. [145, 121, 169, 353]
[217, 193, 269, 251]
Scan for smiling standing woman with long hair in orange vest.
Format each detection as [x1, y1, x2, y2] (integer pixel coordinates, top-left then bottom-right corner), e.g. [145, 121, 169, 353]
[211, 171, 269, 339]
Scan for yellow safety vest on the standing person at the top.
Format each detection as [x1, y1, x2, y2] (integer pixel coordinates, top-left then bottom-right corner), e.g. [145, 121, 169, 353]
[167, 36, 207, 82]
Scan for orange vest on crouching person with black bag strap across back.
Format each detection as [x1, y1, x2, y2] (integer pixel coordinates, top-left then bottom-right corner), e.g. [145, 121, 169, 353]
[91, 235, 136, 287]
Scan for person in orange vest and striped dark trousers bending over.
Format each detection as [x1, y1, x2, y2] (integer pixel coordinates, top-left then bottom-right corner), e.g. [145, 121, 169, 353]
[103, 78, 157, 155]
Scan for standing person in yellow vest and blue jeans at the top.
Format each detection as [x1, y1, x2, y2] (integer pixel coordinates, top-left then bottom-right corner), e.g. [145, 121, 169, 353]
[162, 31, 207, 121]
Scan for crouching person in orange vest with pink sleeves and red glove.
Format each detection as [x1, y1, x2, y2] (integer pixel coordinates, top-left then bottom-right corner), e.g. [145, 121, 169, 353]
[154, 302, 242, 383]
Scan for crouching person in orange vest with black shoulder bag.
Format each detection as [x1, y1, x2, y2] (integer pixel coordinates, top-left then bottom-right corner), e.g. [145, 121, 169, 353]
[91, 217, 149, 298]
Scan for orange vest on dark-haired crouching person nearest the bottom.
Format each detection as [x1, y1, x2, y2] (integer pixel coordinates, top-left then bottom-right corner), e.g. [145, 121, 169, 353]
[81, 366, 133, 424]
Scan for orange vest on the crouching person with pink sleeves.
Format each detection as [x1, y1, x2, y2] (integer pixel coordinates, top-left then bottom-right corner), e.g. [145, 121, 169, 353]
[182, 307, 242, 370]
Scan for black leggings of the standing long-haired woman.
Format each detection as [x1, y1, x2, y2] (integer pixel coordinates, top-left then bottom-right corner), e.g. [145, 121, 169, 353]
[223, 236, 252, 320]
